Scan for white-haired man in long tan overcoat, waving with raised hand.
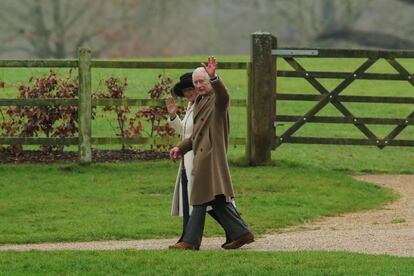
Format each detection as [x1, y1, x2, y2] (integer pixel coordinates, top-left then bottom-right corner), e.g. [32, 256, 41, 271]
[170, 57, 253, 250]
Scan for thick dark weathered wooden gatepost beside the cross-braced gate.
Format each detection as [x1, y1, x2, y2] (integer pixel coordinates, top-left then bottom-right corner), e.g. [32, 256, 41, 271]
[246, 33, 277, 166]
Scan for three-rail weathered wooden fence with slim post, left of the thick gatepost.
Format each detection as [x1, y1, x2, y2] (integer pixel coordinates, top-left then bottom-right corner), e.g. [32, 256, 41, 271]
[0, 48, 247, 164]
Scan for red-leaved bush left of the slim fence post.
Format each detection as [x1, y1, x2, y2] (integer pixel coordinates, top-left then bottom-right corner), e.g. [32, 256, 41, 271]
[0, 71, 79, 154]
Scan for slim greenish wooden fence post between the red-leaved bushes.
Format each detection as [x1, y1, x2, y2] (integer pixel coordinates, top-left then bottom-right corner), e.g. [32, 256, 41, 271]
[78, 48, 92, 165]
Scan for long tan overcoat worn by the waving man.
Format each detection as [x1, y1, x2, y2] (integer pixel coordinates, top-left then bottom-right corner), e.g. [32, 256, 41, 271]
[178, 80, 234, 205]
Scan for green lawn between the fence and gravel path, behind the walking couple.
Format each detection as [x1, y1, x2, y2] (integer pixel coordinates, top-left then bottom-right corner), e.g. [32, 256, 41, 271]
[0, 161, 396, 244]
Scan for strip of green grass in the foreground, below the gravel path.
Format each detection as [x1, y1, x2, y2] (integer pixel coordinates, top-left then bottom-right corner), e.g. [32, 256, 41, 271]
[0, 250, 414, 275]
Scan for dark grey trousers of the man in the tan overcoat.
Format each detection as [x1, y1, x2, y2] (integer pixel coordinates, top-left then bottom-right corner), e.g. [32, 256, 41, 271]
[182, 195, 249, 245]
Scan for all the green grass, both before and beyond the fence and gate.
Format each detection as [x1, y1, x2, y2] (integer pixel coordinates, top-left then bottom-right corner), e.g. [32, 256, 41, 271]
[0, 56, 414, 275]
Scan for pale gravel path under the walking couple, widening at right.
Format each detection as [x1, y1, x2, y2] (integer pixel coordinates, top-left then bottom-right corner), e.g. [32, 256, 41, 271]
[0, 175, 414, 256]
